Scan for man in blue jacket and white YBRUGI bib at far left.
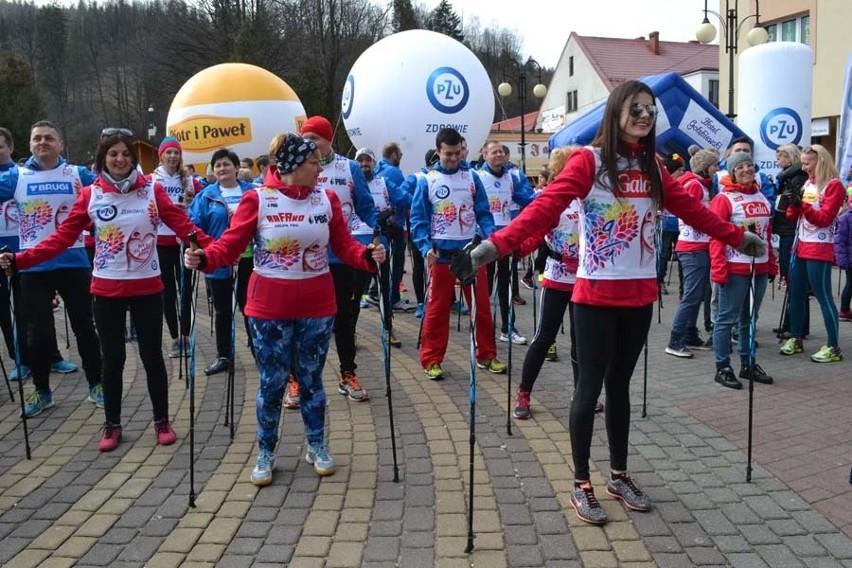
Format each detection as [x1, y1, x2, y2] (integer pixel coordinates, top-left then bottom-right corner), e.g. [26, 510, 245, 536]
[0, 120, 103, 417]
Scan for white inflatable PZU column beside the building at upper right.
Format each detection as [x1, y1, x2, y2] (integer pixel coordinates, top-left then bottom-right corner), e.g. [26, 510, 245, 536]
[736, 41, 814, 176]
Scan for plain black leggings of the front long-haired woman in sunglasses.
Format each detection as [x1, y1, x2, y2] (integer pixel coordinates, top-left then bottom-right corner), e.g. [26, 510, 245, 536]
[569, 304, 653, 481]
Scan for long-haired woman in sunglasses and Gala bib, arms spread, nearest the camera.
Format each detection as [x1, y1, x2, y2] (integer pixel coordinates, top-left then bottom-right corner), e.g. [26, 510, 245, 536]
[458, 81, 765, 524]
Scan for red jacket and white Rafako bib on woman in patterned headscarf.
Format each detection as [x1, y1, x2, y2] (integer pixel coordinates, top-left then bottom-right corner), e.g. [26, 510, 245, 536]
[204, 168, 376, 320]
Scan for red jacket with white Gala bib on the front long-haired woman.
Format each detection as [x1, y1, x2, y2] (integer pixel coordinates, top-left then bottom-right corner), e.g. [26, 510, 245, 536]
[491, 143, 743, 307]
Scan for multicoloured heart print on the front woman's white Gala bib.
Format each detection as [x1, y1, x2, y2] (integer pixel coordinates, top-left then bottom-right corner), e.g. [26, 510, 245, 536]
[583, 199, 639, 274]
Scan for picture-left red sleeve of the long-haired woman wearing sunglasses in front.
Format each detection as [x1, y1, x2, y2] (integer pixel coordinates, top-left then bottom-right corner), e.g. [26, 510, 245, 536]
[489, 148, 595, 256]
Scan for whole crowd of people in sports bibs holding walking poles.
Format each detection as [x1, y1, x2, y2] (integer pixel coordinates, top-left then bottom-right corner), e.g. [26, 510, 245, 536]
[0, 81, 852, 524]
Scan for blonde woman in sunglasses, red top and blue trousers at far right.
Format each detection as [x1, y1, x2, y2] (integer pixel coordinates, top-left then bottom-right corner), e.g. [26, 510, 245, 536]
[781, 144, 846, 363]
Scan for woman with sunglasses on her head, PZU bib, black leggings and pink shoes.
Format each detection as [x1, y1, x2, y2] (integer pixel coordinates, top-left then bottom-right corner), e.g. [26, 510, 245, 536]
[0, 131, 212, 452]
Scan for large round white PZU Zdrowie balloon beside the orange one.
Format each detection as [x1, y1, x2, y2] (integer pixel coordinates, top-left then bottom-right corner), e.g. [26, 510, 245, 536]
[341, 30, 494, 174]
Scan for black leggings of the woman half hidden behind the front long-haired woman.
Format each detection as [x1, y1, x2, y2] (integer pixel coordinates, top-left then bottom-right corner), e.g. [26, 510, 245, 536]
[520, 288, 578, 391]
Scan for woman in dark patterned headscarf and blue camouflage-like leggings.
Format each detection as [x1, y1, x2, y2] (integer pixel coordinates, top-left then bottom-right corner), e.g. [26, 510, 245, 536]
[184, 134, 385, 486]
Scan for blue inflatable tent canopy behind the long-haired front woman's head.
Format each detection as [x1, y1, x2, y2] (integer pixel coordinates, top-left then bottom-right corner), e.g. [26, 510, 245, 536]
[548, 73, 744, 161]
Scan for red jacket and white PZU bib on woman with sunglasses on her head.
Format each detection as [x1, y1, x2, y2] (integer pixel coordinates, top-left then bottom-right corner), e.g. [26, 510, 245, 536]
[15, 175, 212, 298]
